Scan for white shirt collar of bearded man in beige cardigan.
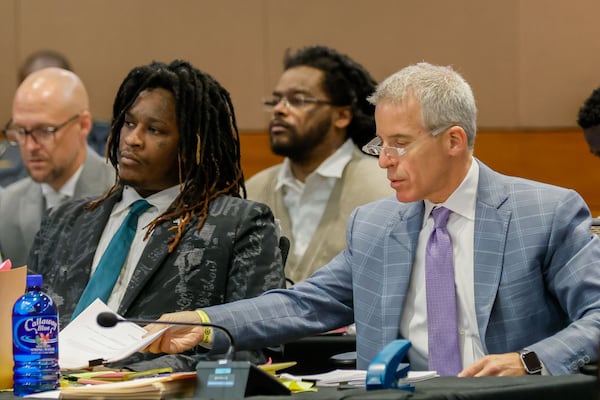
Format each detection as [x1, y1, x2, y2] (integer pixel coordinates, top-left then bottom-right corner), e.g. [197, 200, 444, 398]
[275, 139, 354, 190]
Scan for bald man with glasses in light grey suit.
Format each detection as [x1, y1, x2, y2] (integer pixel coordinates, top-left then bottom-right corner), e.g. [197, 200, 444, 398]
[0, 68, 115, 265]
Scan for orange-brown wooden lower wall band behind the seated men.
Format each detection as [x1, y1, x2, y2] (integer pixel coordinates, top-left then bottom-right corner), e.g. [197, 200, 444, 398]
[241, 130, 600, 216]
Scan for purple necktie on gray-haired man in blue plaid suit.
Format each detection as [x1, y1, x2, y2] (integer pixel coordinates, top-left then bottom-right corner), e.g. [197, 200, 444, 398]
[425, 207, 462, 376]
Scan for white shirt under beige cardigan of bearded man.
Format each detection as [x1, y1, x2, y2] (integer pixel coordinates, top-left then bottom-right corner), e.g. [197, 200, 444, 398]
[275, 139, 354, 259]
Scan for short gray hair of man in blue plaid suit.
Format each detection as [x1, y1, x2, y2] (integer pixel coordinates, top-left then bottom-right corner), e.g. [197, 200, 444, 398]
[367, 62, 477, 149]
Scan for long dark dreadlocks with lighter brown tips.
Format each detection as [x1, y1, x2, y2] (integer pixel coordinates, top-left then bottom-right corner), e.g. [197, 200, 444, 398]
[90, 60, 246, 252]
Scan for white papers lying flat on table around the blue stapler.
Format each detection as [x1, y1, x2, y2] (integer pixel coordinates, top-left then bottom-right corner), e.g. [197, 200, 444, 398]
[280, 369, 439, 386]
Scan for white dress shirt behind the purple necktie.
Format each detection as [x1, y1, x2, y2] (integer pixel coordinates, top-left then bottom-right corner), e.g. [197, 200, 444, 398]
[400, 161, 484, 370]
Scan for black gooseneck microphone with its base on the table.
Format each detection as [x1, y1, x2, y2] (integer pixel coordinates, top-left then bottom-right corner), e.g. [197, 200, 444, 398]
[96, 312, 291, 400]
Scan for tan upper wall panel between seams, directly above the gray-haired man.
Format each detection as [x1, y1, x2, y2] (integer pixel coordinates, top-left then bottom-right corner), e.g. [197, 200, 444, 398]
[266, 0, 519, 127]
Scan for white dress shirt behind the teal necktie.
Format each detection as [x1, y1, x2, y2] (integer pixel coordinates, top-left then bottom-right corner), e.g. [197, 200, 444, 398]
[92, 185, 180, 311]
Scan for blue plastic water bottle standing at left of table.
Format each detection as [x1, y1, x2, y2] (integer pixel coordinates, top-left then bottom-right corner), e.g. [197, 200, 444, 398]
[12, 275, 60, 396]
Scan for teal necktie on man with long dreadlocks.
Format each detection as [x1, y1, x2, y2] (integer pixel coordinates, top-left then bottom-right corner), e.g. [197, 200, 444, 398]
[71, 200, 150, 319]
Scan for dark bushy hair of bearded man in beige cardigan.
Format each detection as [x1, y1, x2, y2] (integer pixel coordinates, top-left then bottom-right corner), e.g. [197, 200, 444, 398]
[283, 46, 377, 148]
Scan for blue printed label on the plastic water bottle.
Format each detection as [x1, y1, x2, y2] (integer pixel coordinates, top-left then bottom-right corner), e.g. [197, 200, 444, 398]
[13, 315, 58, 356]
